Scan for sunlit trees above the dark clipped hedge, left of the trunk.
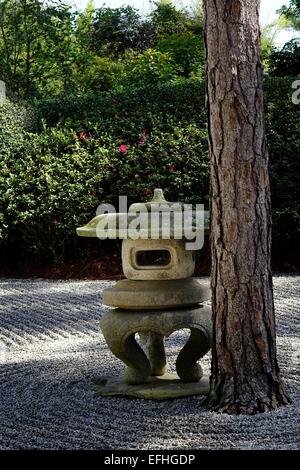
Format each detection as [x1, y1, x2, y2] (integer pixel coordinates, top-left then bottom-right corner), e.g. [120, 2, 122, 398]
[0, 0, 204, 98]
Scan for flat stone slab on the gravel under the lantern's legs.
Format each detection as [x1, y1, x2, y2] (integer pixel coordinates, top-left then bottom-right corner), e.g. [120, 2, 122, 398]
[92, 373, 209, 400]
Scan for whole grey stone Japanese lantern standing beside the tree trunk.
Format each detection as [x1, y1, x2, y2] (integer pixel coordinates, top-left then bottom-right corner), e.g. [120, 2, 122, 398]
[77, 189, 212, 399]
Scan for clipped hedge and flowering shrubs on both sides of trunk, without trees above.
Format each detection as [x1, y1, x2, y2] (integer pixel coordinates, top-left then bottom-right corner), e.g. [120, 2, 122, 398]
[0, 78, 300, 262]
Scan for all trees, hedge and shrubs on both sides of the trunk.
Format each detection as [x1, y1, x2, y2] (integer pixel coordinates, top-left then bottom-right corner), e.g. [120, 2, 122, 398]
[0, 0, 300, 270]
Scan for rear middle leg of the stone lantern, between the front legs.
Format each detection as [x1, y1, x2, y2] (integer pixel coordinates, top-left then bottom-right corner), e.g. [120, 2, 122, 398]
[139, 332, 167, 376]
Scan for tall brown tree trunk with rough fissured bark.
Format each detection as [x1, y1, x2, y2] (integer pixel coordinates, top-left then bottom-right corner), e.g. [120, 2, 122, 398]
[204, 0, 289, 414]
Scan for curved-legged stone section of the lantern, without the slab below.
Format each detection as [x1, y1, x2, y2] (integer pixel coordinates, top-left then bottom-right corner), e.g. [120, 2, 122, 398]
[100, 305, 212, 386]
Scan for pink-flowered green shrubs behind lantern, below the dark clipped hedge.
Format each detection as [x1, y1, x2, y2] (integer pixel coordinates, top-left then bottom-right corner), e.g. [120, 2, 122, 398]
[0, 125, 209, 262]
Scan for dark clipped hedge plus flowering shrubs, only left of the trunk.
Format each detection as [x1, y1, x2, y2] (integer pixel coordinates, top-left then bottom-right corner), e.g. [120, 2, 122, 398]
[0, 82, 209, 262]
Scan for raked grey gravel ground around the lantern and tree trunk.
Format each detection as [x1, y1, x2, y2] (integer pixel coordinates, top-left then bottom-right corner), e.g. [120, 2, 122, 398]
[0, 276, 300, 450]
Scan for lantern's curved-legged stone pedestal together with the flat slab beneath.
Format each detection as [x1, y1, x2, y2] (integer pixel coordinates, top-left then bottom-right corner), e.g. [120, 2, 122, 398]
[94, 305, 212, 399]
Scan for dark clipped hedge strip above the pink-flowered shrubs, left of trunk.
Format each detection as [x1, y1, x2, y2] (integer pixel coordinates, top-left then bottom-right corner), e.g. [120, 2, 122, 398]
[34, 79, 206, 129]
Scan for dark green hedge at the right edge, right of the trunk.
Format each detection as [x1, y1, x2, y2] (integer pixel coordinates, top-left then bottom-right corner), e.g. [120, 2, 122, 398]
[265, 77, 300, 256]
